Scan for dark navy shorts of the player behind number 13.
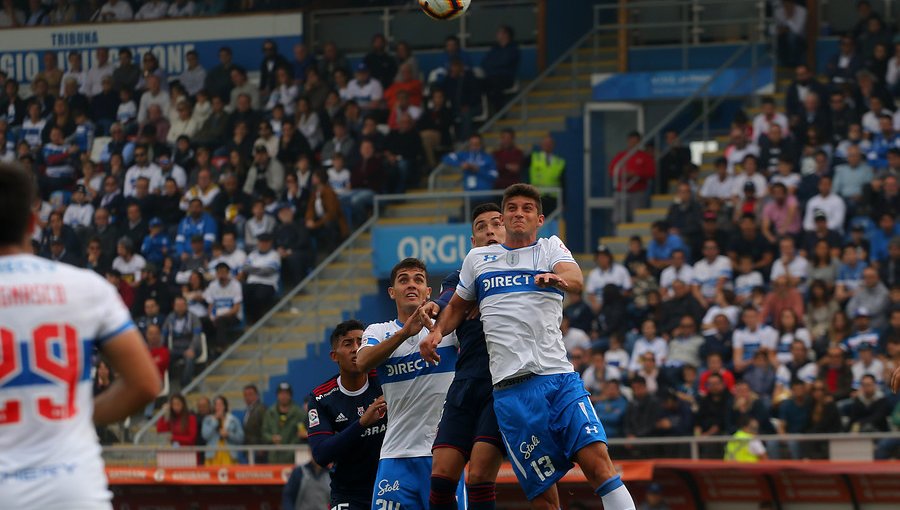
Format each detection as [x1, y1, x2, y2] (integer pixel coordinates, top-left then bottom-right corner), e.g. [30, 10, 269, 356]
[432, 379, 503, 459]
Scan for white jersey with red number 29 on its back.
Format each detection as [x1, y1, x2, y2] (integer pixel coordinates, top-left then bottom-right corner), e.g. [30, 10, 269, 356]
[0, 255, 134, 509]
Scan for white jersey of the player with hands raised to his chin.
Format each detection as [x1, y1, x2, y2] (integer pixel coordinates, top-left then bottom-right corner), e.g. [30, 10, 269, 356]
[360, 320, 459, 459]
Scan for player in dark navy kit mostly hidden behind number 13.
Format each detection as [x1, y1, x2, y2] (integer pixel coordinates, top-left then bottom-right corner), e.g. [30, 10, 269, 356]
[423, 203, 506, 510]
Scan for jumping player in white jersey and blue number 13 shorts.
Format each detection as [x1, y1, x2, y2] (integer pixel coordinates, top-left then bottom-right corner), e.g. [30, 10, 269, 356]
[419, 184, 634, 510]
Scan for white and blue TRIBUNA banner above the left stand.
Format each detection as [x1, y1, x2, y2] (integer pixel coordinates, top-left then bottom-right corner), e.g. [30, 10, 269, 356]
[0, 13, 303, 83]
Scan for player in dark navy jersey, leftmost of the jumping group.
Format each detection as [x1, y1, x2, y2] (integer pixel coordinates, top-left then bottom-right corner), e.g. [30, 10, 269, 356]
[309, 320, 386, 510]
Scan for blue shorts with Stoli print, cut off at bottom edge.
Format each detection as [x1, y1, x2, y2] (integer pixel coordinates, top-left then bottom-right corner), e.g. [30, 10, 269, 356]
[372, 457, 468, 510]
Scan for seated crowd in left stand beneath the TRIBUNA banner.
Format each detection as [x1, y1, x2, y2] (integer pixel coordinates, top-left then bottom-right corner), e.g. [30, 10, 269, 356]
[0, 7, 519, 444]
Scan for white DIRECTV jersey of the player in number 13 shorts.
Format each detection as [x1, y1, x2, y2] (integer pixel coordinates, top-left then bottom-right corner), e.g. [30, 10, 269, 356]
[456, 236, 575, 384]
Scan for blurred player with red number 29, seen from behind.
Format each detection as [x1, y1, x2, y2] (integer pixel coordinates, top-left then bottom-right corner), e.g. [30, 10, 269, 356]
[0, 165, 160, 510]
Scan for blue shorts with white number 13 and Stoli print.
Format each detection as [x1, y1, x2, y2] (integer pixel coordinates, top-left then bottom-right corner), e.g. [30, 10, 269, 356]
[494, 372, 606, 500]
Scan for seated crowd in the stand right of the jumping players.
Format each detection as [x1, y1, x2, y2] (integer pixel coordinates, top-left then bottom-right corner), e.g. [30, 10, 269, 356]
[584, 2, 900, 458]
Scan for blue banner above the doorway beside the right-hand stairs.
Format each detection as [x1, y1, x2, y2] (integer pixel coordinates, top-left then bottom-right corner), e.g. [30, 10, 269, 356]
[591, 67, 774, 101]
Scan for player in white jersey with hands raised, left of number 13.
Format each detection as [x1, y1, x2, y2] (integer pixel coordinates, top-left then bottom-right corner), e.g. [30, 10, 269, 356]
[356, 258, 465, 510]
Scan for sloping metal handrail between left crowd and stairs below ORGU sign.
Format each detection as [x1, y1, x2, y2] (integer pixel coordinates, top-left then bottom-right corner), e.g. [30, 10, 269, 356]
[134, 216, 376, 444]
